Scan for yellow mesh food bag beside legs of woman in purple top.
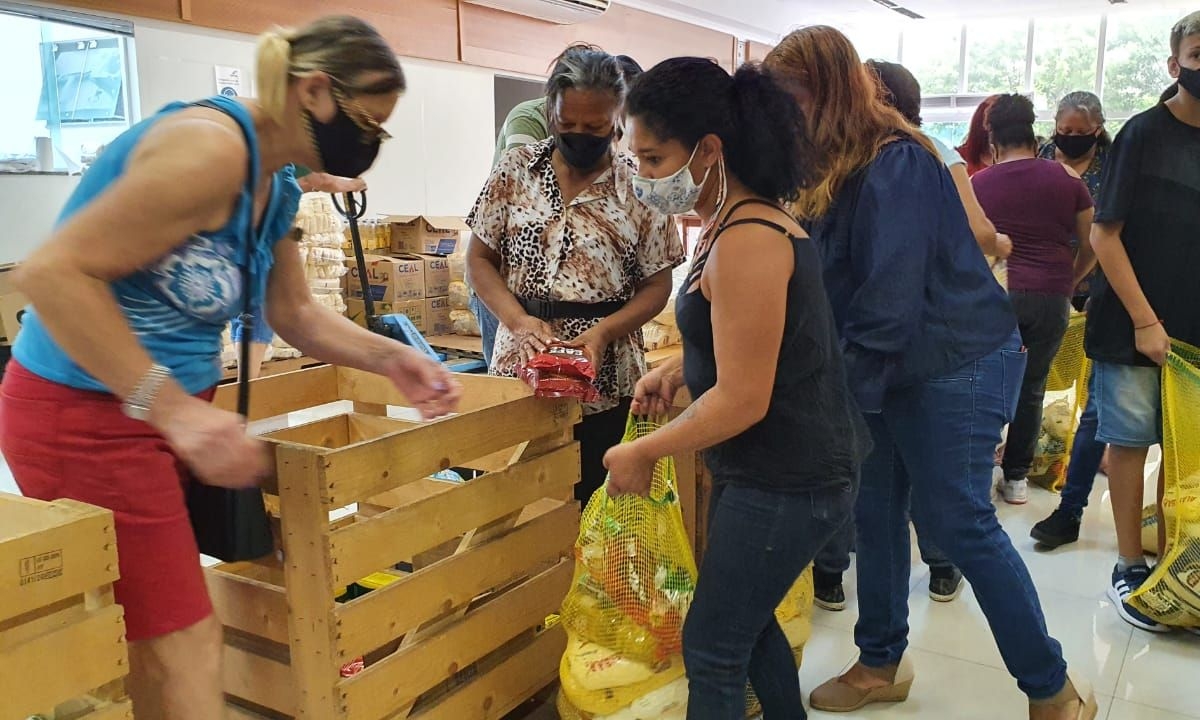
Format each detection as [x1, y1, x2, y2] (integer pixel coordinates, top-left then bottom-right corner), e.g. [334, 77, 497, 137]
[1028, 313, 1092, 492]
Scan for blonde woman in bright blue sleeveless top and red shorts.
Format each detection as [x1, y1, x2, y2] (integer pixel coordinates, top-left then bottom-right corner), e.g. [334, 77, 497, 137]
[0, 17, 458, 720]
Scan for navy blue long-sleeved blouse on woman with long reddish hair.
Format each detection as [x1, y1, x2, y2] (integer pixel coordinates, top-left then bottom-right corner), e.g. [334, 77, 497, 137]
[810, 138, 1016, 413]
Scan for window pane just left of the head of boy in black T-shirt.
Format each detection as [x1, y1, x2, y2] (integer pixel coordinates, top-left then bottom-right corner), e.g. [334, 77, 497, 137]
[1104, 12, 1183, 116]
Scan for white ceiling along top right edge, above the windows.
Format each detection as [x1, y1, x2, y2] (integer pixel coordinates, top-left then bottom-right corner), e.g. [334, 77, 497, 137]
[617, 0, 1196, 41]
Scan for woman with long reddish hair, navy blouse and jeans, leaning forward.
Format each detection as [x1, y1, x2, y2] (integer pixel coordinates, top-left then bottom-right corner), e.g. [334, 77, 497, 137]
[766, 26, 1097, 720]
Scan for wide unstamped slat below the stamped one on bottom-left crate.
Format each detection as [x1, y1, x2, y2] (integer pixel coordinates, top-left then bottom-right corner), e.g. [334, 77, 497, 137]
[0, 605, 128, 718]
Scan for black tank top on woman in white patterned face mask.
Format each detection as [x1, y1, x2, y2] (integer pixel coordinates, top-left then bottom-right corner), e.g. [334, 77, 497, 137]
[676, 199, 870, 492]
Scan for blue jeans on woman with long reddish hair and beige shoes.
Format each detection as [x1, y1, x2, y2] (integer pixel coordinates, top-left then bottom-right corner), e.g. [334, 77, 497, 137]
[854, 334, 1067, 700]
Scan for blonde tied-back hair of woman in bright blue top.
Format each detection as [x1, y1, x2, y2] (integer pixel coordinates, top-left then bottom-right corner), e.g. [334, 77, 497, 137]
[256, 16, 406, 122]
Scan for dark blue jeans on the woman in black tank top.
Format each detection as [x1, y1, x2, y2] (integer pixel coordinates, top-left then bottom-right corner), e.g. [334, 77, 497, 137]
[683, 479, 856, 720]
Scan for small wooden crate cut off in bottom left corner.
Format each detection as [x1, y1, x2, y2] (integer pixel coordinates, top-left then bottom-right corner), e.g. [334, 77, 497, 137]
[0, 493, 133, 720]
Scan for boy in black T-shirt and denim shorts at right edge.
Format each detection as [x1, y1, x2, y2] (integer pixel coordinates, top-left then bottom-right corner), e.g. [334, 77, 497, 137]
[1086, 12, 1200, 632]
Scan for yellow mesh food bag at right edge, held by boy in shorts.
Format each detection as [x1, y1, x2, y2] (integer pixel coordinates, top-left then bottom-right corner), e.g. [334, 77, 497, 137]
[1129, 342, 1200, 628]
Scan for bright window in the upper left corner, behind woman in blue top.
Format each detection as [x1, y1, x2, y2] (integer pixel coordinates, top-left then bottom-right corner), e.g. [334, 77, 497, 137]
[0, 1, 137, 172]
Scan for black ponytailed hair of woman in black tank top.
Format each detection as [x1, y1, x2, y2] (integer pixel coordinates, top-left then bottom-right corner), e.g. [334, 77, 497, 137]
[625, 58, 815, 202]
